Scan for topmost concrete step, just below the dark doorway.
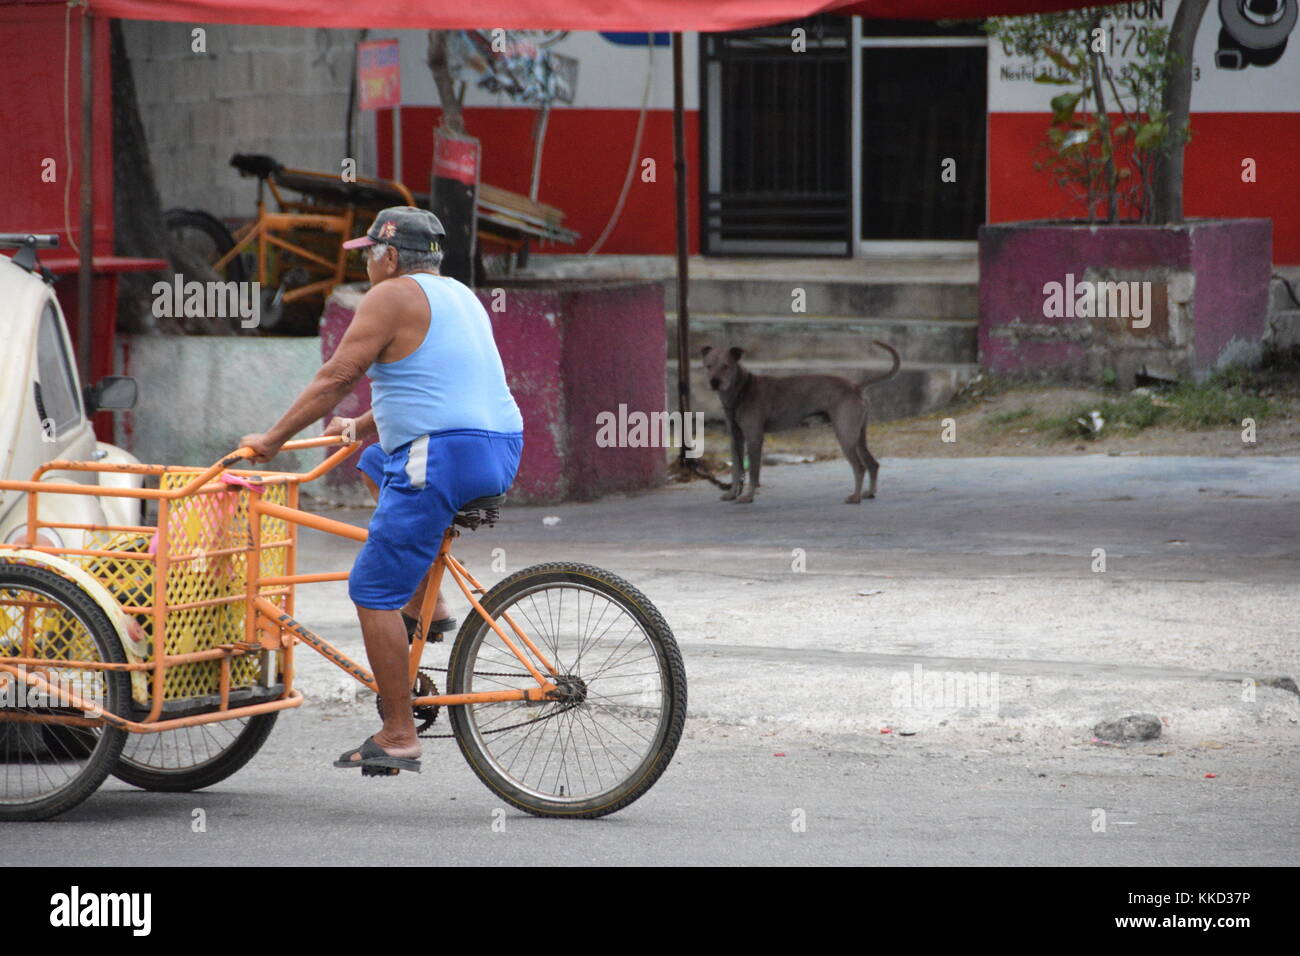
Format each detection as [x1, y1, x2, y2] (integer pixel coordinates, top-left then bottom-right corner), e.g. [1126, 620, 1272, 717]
[663, 277, 979, 320]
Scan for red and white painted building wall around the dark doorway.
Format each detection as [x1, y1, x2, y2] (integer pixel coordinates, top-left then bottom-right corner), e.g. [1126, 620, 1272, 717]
[369, 13, 1300, 264]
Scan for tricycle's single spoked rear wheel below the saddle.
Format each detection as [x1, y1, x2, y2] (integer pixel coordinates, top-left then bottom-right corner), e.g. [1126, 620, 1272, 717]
[449, 562, 686, 818]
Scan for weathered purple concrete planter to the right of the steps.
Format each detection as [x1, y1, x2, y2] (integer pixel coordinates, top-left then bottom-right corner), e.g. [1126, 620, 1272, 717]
[979, 220, 1273, 384]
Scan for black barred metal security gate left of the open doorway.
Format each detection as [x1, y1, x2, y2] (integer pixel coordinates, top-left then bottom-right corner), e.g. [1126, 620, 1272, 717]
[699, 17, 853, 256]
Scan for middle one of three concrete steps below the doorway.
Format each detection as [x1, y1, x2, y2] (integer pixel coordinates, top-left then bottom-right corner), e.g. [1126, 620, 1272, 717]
[666, 312, 979, 364]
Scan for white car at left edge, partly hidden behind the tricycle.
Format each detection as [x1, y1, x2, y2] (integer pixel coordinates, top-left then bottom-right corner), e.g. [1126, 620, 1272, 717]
[0, 234, 142, 548]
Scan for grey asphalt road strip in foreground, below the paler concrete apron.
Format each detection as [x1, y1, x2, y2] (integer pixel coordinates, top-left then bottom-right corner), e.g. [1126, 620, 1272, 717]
[0, 708, 1296, 866]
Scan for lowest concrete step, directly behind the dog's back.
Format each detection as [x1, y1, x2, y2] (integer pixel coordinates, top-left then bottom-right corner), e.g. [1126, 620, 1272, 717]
[667, 359, 979, 421]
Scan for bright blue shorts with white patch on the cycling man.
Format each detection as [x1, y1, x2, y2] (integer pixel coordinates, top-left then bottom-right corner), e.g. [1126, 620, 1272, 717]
[347, 428, 524, 610]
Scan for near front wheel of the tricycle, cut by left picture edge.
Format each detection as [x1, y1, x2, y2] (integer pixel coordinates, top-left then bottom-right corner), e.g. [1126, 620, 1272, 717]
[0, 563, 130, 821]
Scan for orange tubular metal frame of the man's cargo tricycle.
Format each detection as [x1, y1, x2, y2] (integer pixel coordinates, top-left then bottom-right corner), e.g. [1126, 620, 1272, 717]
[0, 436, 558, 734]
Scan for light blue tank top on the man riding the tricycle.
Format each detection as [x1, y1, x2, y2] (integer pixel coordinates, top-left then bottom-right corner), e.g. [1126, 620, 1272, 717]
[367, 273, 524, 454]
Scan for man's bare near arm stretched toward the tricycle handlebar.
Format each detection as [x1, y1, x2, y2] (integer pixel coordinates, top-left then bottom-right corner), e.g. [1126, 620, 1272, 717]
[239, 282, 399, 462]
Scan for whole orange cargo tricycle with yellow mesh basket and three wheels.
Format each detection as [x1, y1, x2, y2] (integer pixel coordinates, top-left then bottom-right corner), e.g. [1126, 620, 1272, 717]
[0, 436, 686, 819]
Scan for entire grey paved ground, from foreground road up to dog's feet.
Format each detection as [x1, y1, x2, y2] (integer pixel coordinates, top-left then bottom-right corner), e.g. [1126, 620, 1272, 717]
[0, 457, 1300, 865]
